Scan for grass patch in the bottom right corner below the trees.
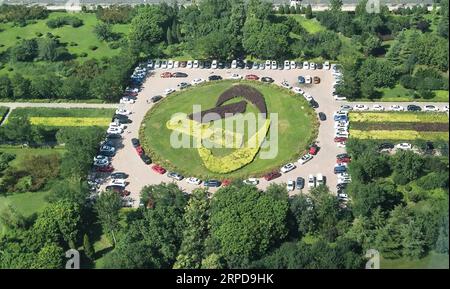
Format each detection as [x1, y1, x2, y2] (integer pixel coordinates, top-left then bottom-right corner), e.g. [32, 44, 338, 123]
[380, 252, 449, 269]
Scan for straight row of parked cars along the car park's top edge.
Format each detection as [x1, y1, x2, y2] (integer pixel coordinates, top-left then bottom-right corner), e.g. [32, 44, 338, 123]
[147, 59, 331, 70]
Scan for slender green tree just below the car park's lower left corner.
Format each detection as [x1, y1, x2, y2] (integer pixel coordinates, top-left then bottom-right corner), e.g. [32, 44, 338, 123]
[95, 191, 122, 245]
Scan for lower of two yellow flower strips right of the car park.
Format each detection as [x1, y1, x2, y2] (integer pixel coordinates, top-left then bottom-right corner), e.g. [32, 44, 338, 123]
[351, 130, 449, 141]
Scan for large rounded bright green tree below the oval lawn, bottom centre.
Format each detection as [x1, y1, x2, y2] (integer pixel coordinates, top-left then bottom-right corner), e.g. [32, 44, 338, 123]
[210, 186, 288, 268]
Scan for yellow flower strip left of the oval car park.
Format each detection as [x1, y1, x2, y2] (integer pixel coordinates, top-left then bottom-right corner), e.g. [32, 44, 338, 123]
[29, 117, 111, 127]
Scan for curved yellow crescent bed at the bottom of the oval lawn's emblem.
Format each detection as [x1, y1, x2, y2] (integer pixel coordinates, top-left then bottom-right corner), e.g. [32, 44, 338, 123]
[198, 120, 270, 174]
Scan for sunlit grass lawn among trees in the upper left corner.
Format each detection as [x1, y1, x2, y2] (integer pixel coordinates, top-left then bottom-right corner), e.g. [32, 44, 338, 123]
[0, 12, 129, 76]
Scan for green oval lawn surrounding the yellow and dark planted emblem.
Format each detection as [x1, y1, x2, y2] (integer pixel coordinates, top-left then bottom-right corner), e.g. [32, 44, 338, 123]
[140, 81, 318, 178]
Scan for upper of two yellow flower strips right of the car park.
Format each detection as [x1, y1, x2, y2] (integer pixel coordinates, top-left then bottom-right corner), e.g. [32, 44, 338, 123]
[350, 112, 448, 123]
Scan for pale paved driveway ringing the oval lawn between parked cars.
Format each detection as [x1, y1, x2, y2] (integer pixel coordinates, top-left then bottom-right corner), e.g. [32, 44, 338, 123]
[105, 68, 445, 205]
